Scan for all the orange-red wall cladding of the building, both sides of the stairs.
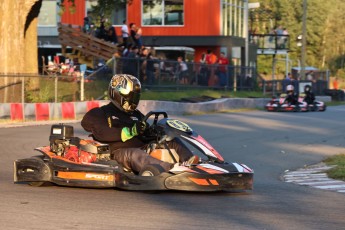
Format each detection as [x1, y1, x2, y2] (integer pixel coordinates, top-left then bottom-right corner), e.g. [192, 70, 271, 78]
[61, 0, 221, 61]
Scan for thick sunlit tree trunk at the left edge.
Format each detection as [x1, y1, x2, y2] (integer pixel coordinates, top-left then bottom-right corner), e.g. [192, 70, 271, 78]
[0, 0, 42, 74]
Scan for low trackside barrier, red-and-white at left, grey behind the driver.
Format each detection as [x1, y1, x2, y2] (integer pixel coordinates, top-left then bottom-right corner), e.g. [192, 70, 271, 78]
[0, 96, 331, 121]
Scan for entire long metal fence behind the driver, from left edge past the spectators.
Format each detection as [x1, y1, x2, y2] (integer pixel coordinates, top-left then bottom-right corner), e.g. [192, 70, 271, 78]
[0, 58, 257, 103]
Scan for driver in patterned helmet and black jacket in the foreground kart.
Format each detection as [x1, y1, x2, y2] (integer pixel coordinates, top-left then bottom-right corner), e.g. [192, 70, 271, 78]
[81, 74, 198, 173]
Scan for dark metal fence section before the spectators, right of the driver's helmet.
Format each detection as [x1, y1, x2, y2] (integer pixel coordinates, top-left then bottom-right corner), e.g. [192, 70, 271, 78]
[113, 57, 257, 90]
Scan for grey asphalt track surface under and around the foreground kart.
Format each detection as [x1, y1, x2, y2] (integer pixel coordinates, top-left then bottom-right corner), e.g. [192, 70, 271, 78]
[0, 106, 345, 230]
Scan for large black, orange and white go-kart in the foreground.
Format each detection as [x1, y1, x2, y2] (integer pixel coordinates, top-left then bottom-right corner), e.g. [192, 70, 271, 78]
[14, 111, 254, 192]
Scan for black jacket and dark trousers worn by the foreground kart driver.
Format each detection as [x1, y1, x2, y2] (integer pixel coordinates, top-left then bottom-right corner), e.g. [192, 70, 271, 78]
[81, 102, 193, 173]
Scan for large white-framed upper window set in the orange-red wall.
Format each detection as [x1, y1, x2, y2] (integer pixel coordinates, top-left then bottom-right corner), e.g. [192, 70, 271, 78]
[142, 0, 184, 26]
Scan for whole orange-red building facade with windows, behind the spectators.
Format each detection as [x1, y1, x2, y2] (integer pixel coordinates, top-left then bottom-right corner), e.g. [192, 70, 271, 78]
[38, 0, 256, 66]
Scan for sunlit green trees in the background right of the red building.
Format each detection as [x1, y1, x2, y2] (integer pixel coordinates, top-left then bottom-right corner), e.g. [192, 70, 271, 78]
[249, 0, 345, 74]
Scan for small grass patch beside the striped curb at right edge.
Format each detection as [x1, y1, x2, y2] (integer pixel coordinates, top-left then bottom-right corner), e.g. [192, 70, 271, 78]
[323, 154, 345, 181]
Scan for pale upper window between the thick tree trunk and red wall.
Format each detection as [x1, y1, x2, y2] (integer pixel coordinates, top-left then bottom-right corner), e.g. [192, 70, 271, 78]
[38, 0, 57, 26]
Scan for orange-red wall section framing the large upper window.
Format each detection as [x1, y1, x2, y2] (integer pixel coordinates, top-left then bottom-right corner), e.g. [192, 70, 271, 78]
[127, 0, 221, 36]
